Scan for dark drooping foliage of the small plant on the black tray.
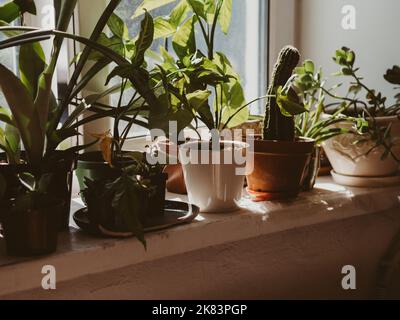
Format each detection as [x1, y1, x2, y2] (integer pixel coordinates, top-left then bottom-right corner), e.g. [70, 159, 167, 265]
[82, 152, 163, 247]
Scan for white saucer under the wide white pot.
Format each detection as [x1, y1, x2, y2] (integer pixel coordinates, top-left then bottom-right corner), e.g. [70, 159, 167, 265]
[331, 170, 400, 188]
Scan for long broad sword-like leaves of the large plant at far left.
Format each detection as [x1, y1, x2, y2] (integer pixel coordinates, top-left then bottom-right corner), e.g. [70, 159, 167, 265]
[0, 0, 120, 168]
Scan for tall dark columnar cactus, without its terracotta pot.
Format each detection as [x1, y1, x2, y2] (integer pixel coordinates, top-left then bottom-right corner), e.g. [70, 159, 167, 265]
[263, 46, 304, 141]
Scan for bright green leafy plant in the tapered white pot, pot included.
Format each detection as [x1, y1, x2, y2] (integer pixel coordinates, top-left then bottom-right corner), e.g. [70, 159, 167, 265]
[141, 0, 262, 212]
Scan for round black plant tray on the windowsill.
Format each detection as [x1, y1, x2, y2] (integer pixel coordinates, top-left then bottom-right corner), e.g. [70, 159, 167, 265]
[73, 201, 200, 238]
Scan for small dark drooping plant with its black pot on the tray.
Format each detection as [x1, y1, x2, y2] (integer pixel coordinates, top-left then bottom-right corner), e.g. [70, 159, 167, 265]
[82, 152, 167, 246]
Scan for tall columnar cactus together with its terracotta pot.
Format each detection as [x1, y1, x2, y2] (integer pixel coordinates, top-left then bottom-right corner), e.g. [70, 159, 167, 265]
[247, 46, 315, 201]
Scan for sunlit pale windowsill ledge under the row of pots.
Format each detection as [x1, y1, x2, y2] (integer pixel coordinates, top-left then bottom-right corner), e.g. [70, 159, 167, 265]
[0, 178, 400, 296]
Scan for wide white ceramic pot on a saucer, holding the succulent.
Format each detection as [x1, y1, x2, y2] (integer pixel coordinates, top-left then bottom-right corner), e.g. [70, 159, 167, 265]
[323, 116, 400, 177]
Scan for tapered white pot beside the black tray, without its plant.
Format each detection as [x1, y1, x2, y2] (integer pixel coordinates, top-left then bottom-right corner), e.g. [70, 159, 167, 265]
[179, 141, 248, 213]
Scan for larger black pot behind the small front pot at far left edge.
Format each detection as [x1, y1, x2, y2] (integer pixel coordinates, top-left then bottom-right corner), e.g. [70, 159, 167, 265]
[0, 153, 77, 231]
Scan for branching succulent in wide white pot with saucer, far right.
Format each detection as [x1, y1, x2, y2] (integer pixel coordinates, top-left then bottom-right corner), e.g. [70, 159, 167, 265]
[321, 48, 400, 186]
